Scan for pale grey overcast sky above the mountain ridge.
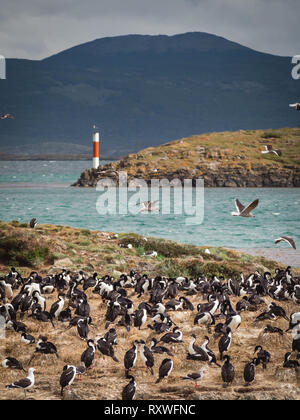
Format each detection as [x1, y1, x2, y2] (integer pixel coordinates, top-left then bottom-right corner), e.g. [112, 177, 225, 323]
[0, 0, 300, 59]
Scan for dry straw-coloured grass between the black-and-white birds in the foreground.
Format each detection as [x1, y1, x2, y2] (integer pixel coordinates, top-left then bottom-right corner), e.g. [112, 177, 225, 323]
[0, 293, 297, 400]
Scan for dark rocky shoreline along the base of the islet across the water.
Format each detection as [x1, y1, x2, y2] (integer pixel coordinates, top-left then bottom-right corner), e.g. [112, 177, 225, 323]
[73, 149, 300, 188]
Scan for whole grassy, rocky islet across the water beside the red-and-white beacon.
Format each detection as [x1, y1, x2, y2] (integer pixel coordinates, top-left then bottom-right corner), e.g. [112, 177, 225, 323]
[73, 128, 300, 188]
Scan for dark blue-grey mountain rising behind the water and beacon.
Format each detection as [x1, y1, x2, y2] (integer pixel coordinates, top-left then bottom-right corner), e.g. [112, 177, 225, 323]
[0, 32, 300, 156]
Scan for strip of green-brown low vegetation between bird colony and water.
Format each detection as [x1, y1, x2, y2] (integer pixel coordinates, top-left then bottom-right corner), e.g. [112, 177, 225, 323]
[0, 221, 296, 277]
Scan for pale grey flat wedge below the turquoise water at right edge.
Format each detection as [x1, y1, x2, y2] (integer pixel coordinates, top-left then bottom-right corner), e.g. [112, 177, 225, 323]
[238, 248, 300, 268]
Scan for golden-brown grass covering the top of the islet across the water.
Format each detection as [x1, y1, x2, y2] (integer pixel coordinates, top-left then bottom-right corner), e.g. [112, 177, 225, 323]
[111, 128, 300, 177]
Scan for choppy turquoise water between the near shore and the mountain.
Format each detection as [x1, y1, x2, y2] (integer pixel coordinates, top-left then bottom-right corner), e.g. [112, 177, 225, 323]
[0, 161, 300, 248]
